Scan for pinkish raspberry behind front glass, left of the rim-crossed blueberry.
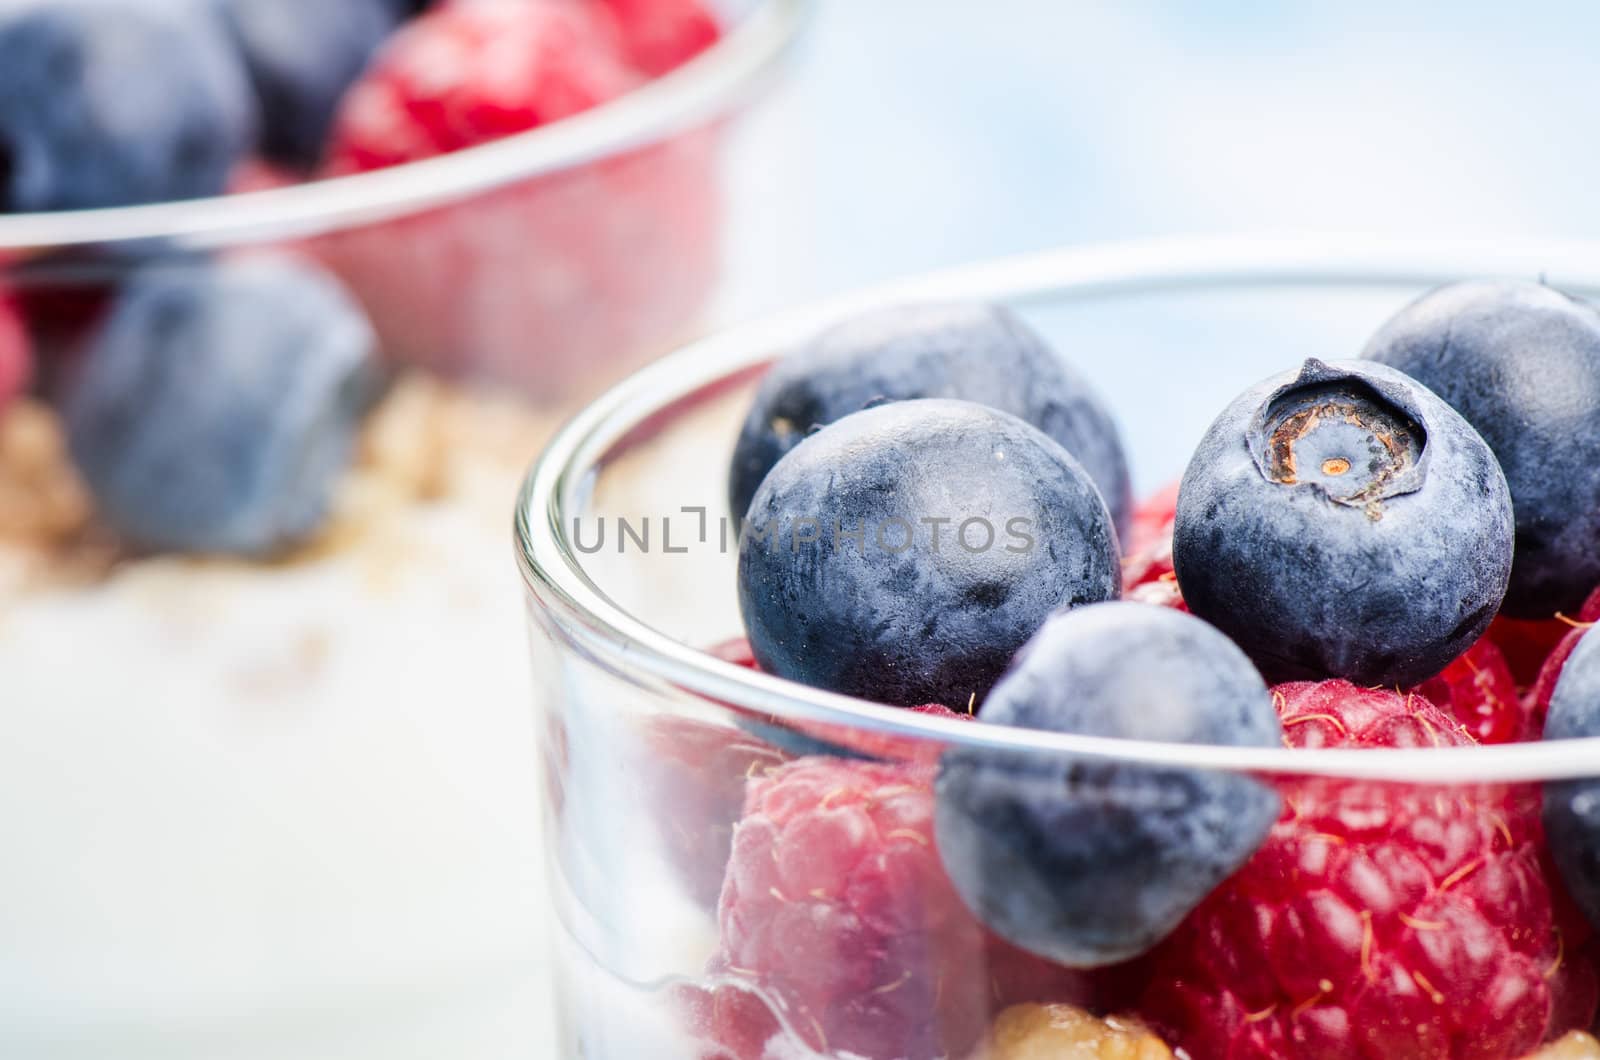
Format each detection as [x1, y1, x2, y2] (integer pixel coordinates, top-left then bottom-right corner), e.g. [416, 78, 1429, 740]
[712, 757, 1085, 1060]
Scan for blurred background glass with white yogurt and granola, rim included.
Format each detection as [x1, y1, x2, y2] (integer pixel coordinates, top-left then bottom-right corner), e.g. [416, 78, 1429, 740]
[0, 0, 811, 1060]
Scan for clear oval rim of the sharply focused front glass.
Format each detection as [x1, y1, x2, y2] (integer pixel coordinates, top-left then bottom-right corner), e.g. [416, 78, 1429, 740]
[514, 234, 1600, 785]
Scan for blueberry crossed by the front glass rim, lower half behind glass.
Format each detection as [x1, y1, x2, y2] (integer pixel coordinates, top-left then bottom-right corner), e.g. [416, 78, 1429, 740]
[934, 602, 1283, 967]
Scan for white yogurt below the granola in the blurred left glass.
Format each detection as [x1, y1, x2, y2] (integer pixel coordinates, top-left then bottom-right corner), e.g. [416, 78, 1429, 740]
[0, 479, 544, 1060]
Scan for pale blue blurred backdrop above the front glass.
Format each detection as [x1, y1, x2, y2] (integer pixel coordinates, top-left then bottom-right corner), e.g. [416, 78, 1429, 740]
[723, 0, 1600, 317]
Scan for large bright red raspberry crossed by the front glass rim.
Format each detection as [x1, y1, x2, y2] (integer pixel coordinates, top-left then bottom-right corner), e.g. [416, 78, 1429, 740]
[1142, 681, 1594, 1060]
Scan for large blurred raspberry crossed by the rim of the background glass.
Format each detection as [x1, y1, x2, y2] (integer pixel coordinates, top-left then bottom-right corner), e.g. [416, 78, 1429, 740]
[317, 0, 720, 397]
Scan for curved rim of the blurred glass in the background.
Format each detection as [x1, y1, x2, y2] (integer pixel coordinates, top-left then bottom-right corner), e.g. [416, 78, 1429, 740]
[0, 0, 814, 251]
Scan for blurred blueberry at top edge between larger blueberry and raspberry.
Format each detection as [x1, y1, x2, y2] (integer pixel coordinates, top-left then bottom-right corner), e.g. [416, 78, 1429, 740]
[214, 0, 402, 168]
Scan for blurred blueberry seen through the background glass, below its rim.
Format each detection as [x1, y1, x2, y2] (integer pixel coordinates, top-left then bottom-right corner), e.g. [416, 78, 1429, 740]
[64, 256, 374, 554]
